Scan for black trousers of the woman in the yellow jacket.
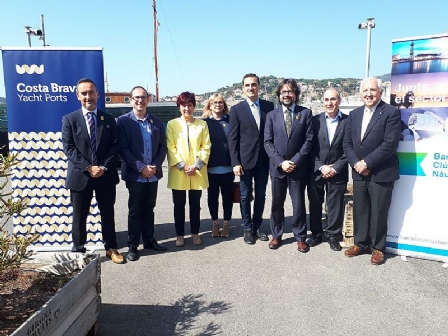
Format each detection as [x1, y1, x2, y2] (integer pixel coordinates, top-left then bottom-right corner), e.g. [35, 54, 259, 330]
[172, 189, 202, 236]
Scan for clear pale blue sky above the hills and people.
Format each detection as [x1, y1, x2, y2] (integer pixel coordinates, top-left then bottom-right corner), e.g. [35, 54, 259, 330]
[0, 0, 448, 97]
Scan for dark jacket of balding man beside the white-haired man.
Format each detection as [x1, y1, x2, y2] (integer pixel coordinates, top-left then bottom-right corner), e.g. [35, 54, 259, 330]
[310, 112, 348, 183]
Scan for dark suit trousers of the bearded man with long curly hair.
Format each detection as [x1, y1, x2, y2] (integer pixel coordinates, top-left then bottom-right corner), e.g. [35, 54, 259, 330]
[270, 176, 306, 241]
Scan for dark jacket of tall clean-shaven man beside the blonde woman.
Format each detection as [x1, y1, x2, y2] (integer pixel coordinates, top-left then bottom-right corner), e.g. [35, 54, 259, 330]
[228, 99, 274, 169]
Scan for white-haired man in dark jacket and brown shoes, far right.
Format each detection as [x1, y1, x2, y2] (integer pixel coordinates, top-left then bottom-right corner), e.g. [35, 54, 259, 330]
[344, 77, 401, 265]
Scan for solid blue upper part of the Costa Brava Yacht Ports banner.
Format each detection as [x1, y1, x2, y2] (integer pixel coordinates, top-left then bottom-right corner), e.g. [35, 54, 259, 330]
[2, 48, 105, 132]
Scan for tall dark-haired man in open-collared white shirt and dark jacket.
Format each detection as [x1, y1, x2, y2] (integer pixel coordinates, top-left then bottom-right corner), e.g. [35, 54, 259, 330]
[228, 73, 274, 244]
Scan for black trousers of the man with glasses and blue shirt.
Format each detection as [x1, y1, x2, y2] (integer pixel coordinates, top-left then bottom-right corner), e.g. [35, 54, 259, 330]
[126, 181, 159, 247]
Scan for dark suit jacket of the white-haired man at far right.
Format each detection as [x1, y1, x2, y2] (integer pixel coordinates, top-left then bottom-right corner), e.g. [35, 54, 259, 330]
[344, 101, 401, 182]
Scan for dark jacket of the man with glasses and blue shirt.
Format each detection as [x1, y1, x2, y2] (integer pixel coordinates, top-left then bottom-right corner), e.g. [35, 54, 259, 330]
[117, 111, 167, 181]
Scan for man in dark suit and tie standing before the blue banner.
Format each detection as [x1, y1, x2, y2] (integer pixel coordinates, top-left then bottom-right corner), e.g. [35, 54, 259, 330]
[62, 78, 124, 264]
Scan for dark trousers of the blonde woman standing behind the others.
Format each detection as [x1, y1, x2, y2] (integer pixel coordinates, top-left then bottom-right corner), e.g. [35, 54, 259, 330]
[207, 172, 235, 221]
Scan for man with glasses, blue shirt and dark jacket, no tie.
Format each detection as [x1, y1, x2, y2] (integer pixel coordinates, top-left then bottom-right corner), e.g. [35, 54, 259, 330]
[117, 86, 167, 261]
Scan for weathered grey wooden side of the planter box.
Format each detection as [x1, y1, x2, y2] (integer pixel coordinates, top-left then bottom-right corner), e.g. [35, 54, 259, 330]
[11, 255, 101, 336]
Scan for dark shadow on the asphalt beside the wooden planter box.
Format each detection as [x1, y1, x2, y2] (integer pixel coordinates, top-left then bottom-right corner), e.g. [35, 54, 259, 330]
[98, 294, 232, 336]
